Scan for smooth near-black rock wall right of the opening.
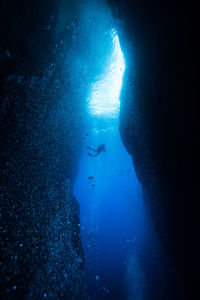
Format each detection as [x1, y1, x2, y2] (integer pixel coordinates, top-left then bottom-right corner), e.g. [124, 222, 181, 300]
[108, 0, 197, 299]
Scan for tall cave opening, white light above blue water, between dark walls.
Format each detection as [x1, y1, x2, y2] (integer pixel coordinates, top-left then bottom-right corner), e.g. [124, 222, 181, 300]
[74, 25, 170, 299]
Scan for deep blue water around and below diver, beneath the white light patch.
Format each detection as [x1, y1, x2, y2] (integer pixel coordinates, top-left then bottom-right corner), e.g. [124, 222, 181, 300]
[74, 116, 143, 294]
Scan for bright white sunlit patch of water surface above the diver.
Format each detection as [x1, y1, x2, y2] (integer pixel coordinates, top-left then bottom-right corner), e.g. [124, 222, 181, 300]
[89, 31, 125, 118]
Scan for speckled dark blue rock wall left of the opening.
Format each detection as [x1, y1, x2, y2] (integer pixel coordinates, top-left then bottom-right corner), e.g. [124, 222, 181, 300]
[0, 0, 86, 300]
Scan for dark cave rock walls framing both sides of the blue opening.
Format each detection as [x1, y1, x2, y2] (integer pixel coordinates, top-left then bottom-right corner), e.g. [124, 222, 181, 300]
[0, 0, 200, 299]
